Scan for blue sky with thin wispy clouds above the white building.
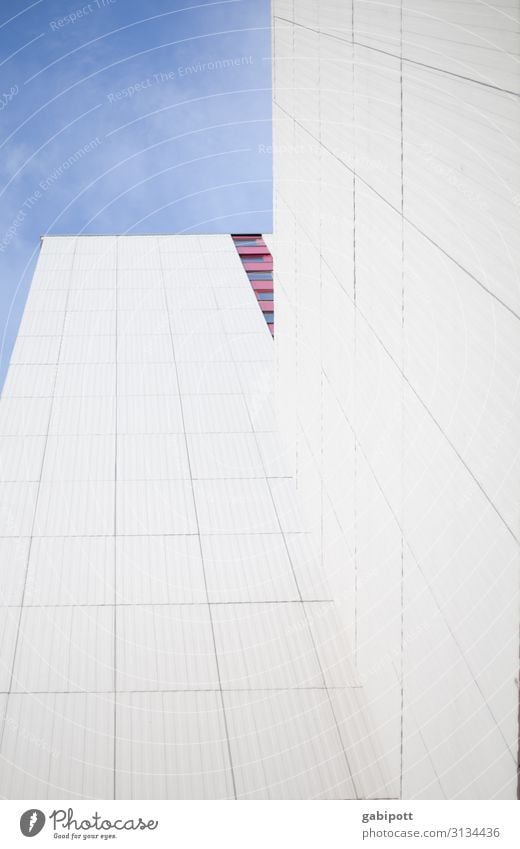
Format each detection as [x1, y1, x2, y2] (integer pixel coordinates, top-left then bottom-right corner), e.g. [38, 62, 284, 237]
[0, 0, 272, 386]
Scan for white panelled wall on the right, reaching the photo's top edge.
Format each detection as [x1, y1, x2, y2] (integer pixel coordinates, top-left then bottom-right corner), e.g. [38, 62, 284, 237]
[270, 0, 520, 798]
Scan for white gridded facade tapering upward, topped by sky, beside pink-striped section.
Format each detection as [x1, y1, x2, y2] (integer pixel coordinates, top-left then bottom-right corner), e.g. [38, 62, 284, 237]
[0, 236, 385, 799]
